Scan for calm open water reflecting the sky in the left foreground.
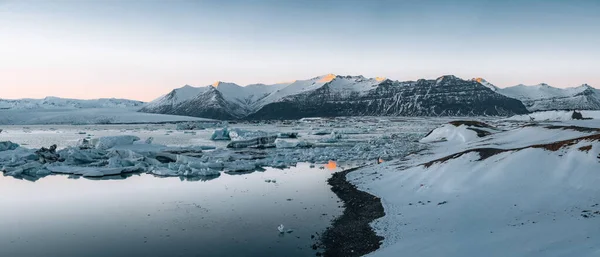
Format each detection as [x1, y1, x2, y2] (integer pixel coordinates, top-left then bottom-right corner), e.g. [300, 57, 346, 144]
[0, 164, 343, 257]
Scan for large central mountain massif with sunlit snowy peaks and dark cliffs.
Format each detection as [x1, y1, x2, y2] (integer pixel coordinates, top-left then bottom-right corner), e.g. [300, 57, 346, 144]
[141, 74, 527, 119]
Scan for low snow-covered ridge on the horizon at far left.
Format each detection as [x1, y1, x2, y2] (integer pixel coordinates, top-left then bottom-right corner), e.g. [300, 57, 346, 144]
[0, 97, 144, 110]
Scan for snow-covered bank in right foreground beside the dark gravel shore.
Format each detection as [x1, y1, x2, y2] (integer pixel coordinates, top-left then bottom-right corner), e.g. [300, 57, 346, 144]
[347, 120, 600, 256]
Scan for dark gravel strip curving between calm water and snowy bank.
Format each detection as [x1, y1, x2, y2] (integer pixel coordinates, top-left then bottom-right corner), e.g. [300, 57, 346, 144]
[321, 168, 385, 257]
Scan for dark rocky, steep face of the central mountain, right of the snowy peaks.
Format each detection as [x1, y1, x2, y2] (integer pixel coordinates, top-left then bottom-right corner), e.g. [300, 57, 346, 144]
[247, 76, 528, 119]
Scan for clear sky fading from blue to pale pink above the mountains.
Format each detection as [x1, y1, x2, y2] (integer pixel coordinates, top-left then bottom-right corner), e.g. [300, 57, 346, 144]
[0, 0, 600, 101]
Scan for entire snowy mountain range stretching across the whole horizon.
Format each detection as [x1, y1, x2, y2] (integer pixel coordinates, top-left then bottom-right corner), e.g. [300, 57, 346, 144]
[5, 74, 600, 120]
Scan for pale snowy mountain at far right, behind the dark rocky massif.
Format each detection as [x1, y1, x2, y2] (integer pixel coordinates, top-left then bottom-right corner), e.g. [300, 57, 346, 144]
[497, 83, 600, 111]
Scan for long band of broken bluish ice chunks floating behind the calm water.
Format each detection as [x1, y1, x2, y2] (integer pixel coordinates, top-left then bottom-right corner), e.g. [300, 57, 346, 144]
[0, 115, 432, 179]
